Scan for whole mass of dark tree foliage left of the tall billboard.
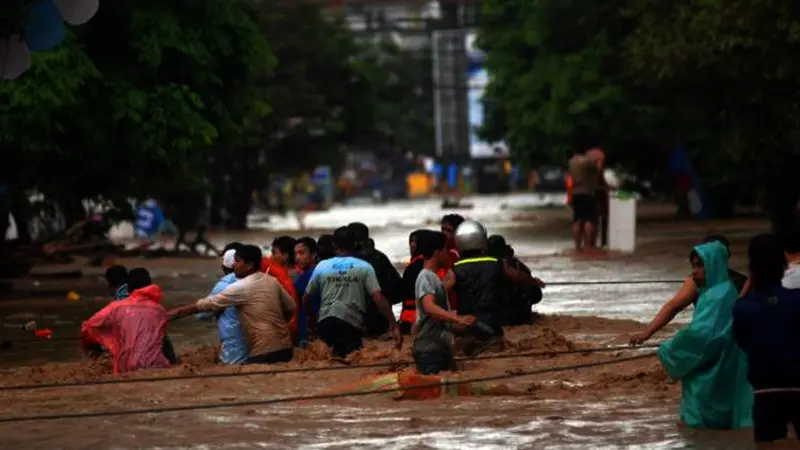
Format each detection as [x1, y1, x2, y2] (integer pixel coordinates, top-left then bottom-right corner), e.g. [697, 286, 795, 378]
[0, 0, 438, 237]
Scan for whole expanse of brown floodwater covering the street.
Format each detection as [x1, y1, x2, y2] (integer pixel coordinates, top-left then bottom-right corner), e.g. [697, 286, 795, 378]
[0, 196, 776, 450]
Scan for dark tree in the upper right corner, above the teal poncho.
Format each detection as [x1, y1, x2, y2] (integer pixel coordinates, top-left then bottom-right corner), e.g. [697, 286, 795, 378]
[624, 0, 800, 223]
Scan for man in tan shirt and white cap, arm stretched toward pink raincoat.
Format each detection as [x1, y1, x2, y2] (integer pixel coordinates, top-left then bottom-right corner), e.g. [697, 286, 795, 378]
[168, 245, 295, 364]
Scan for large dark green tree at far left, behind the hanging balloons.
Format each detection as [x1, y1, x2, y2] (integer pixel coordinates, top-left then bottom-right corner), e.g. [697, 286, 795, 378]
[0, 0, 274, 237]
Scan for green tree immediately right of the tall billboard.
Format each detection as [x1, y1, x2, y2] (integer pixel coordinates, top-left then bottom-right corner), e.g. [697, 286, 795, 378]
[478, 0, 641, 169]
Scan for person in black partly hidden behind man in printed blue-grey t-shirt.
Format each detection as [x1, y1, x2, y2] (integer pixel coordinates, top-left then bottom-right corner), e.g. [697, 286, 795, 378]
[347, 222, 404, 337]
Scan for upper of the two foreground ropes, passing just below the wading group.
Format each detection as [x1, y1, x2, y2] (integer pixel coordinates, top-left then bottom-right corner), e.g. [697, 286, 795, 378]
[0, 344, 658, 391]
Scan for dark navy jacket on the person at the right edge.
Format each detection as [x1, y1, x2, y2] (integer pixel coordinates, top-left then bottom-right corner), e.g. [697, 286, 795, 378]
[733, 285, 800, 390]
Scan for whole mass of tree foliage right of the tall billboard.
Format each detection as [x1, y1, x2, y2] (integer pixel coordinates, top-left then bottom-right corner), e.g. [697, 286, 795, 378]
[480, 0, 800, 224]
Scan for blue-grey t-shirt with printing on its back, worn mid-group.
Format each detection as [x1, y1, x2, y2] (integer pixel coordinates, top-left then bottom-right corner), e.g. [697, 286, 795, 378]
[306, 256, 381, 330]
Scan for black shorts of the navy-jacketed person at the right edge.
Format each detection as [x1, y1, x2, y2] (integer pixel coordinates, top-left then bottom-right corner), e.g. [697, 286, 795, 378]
[753, 392, 800, 442]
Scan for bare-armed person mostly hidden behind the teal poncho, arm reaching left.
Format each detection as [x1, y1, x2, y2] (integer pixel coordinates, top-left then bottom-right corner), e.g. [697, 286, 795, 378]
[630, 234, 748, 345]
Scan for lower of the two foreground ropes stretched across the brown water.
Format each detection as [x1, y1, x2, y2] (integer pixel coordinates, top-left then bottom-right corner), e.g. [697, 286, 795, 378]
[0, 353, 656, 423]
